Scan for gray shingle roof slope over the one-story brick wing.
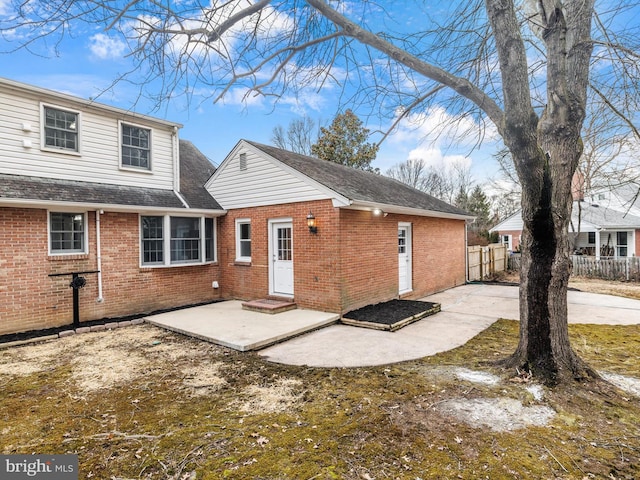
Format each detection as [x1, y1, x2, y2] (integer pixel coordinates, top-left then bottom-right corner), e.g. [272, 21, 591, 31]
[247, 141, 472, 217]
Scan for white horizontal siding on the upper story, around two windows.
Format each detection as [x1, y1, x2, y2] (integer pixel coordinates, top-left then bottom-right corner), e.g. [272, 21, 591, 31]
[0, 82, 177, 190]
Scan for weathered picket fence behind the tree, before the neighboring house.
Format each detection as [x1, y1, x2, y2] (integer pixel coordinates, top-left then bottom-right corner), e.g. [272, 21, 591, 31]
[507, 254, 640, 282]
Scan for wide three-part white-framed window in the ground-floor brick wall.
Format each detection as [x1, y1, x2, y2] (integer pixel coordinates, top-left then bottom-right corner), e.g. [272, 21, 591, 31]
[140, 215, 216, 267]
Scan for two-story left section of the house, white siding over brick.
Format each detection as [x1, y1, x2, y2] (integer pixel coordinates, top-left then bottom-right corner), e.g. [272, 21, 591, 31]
[0, 79, 225, 334]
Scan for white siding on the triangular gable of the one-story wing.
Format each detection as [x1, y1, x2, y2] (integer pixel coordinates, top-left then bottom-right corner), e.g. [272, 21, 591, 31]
[207, 144, 331, 209]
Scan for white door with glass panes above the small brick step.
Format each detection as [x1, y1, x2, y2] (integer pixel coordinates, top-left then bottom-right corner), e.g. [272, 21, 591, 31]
[270, 222, 293, 296]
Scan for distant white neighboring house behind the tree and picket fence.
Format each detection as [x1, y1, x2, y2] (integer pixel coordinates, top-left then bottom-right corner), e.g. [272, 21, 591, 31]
[490, 201, 640, 258]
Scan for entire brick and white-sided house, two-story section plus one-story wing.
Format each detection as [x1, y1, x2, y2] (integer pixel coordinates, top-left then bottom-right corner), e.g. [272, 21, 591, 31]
[0, 79, 471, 335]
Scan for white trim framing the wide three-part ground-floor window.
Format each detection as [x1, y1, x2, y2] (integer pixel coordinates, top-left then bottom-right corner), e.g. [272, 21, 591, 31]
[138, 213, 218, 268]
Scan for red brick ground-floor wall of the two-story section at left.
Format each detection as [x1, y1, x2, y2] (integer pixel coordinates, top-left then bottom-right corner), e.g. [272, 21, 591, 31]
[0, 208, 219, 335]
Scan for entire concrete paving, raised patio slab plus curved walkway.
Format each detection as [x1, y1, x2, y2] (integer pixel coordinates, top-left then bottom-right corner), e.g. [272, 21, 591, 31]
[145, 284, 640, 367]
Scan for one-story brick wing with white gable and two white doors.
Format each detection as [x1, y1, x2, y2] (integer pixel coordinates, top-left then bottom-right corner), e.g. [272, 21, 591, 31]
[206, 140, 473, 313]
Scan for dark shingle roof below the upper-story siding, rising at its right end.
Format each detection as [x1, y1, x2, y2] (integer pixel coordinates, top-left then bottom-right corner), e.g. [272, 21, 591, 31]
[0, 140, 222, 210]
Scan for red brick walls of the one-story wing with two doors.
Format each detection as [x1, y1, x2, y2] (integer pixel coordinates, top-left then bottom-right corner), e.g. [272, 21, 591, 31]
[219, 201, 465, 313]
